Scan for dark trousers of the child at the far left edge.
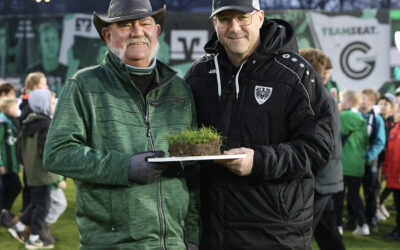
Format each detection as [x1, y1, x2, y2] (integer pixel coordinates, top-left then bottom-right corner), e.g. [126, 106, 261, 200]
[1, 173, 22, 211]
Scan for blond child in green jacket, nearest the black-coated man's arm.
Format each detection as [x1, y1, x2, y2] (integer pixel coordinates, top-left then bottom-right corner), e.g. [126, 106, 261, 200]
[337, 90, 370, 236]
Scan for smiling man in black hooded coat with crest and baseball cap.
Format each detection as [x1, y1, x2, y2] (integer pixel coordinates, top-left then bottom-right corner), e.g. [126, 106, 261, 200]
[185, 0, 333, 250]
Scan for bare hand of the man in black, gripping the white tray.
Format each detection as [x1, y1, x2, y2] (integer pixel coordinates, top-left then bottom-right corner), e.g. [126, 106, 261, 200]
[215, 148, 254, 176]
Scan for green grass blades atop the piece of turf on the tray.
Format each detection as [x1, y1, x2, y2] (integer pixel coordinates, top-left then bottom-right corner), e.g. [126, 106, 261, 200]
[168, 127, 222, 144]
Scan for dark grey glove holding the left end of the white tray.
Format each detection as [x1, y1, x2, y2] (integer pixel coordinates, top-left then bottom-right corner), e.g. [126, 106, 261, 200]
[128, 151, 169, 184]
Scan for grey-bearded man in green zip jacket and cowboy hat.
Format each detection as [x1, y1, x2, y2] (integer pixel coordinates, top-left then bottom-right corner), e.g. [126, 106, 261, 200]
[44, 0, 199, 250]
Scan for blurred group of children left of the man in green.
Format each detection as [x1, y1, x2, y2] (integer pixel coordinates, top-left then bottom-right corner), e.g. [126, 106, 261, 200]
[0, 72, 67, 247]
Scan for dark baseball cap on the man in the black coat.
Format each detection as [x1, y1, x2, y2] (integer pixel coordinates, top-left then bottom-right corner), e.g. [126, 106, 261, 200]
[210, 0, 260, 18]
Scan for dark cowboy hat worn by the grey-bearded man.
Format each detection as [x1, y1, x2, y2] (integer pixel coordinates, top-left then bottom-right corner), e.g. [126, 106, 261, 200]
[93, 0, 167, 41]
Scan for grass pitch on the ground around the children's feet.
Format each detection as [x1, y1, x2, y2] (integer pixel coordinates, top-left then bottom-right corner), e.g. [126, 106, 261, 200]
[0, 179, 400, 250]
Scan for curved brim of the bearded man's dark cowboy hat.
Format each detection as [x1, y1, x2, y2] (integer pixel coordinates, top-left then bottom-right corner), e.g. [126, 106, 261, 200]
[93, 5, 167, 41]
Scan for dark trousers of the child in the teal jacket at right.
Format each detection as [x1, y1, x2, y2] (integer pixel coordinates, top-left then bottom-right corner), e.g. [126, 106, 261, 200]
[363, 161, 379, 225]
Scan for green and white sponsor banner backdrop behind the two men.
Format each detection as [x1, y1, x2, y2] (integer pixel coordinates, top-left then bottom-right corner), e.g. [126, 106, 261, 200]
[0, 10, 390, 93]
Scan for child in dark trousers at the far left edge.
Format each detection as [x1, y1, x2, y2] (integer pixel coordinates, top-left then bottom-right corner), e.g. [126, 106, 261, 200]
[0, 97, 22, 227]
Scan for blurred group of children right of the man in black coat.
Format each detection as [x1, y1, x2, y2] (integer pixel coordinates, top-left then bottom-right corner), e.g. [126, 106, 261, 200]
[300, 48, 400, 243]
